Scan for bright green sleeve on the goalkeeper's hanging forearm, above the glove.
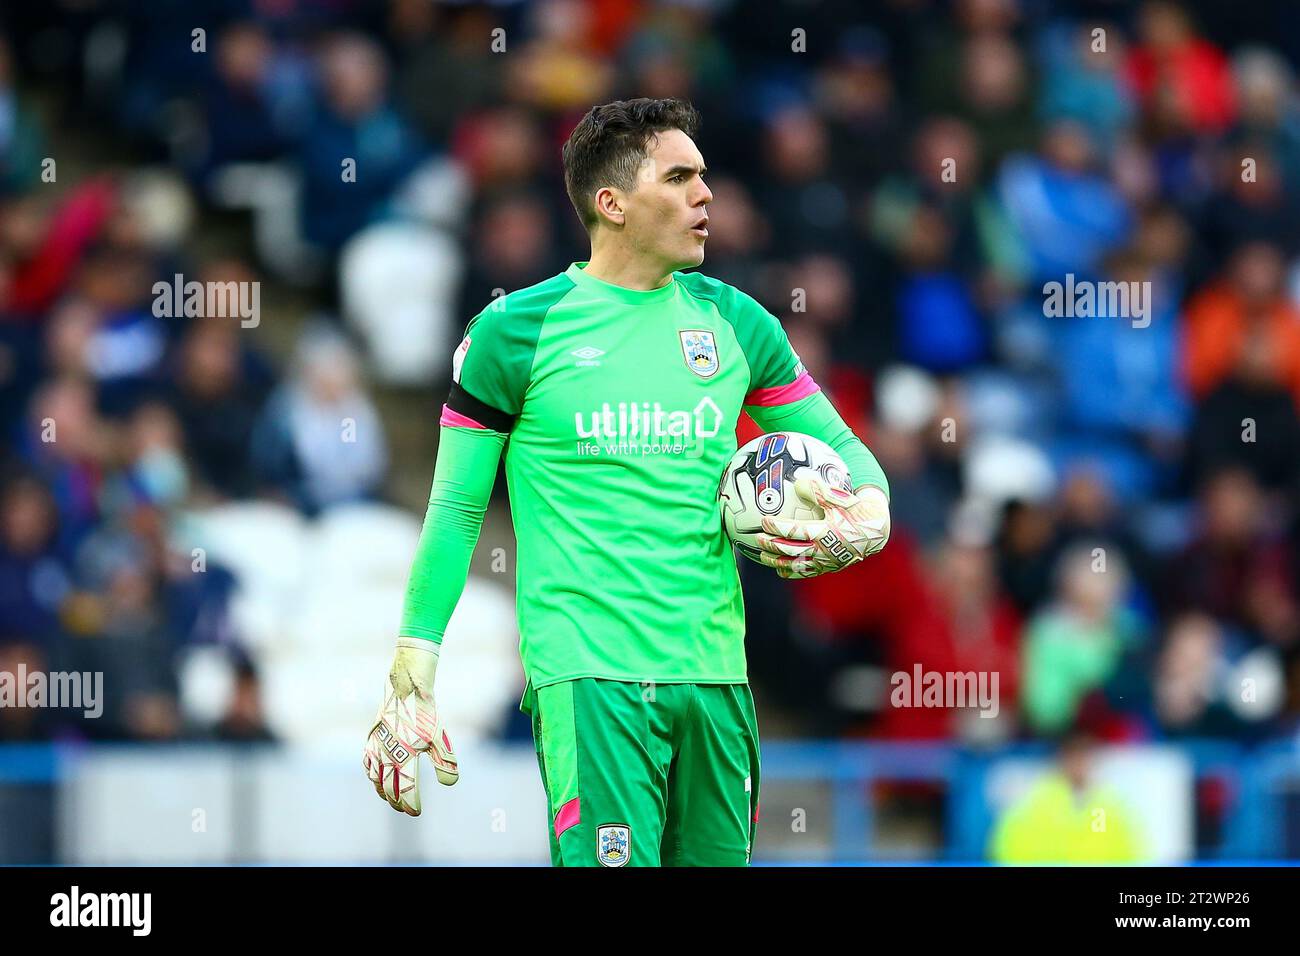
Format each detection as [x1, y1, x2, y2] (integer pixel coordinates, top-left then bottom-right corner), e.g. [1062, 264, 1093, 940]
[398, 424, 506, 644]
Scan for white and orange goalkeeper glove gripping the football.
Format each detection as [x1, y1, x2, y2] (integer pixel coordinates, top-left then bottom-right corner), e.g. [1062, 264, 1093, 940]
[758, 477, 889, 578]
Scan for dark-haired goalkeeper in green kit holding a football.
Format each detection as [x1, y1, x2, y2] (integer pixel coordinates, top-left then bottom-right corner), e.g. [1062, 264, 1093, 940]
[364, 99, 889, 866]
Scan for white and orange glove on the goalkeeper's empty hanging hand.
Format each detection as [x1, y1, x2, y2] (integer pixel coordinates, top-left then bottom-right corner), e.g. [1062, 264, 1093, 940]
[361, 637, 460, 817]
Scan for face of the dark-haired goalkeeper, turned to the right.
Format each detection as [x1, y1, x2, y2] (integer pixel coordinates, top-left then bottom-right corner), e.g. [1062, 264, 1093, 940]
[615, 130, 714, 274]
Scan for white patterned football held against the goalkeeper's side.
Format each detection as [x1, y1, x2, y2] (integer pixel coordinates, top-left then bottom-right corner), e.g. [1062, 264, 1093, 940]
[718, 432, 853, 561]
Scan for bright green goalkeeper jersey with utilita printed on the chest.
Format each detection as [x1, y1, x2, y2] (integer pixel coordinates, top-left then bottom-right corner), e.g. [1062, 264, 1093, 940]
[402, 263, 888, 688]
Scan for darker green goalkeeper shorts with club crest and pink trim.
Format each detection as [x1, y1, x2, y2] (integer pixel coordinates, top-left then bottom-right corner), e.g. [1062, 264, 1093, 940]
[521, 678, 758, 866]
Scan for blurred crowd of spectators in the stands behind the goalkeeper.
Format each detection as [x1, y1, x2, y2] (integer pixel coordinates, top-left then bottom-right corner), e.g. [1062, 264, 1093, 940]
[0, 0, 1300, 764]
